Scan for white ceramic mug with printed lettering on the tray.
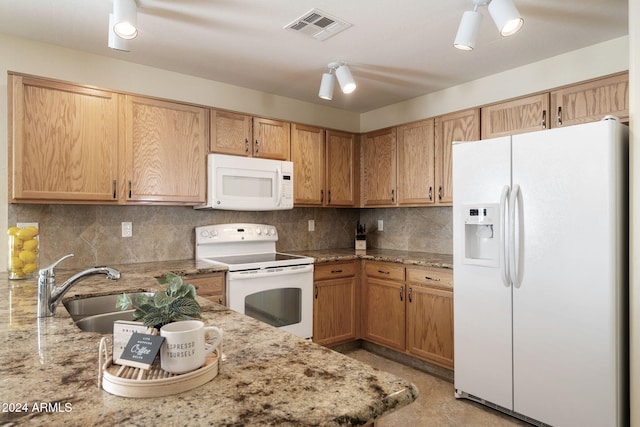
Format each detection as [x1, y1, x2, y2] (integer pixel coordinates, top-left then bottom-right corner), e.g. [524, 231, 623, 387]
[160, 320, 222, 374]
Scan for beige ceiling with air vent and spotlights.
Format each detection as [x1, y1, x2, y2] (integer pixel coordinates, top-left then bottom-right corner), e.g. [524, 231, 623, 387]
[0, 0, 628, 112]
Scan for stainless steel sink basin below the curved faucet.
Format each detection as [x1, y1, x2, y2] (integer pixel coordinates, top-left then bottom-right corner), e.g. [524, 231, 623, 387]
[64, 292, 152, 334]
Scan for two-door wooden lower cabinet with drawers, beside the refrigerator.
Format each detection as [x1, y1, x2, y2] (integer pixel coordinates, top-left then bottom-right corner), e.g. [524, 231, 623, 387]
[362, 261, 453, 369]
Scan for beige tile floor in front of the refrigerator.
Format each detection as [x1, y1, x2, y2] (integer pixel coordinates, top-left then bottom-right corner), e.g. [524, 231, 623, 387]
[344, 349, 530, 427]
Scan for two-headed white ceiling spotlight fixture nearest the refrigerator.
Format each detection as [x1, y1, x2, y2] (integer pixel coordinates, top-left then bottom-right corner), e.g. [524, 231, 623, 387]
[453, 0, 524, 50]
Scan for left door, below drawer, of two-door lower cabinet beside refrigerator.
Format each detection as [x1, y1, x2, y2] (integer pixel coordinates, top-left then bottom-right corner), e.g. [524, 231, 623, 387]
[363, 277, 405, 351]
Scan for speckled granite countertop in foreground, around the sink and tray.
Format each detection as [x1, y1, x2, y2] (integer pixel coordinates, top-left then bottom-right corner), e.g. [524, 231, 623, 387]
[0, 258, 418, 426]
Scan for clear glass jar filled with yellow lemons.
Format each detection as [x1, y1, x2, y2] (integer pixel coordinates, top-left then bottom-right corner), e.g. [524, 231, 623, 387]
[7, 225, 39, 279]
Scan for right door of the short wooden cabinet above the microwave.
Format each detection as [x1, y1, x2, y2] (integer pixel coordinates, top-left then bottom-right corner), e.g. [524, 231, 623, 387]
[253, 117, 291, 160]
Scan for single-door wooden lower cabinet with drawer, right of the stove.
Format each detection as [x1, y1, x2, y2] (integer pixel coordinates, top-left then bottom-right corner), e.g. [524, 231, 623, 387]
[313, 260, 359, 346]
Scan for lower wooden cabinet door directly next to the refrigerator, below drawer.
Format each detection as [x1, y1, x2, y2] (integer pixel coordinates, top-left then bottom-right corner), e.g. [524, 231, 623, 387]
[407, 284, 453, 368]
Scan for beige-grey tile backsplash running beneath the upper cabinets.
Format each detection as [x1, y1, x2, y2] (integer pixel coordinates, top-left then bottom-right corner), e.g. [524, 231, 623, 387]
[9, 204, 453, 267]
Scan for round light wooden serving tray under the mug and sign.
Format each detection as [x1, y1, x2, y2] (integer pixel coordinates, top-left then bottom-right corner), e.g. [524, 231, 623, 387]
[98, 337, 220, 398]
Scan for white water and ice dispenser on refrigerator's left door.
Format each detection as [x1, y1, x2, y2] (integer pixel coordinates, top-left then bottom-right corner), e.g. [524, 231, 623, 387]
[464, 203, 500, 267]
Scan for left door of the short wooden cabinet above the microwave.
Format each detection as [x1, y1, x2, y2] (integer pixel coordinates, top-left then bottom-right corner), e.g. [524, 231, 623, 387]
[209, 110, 252, 156]
